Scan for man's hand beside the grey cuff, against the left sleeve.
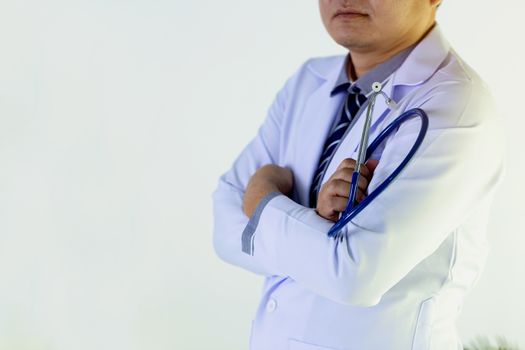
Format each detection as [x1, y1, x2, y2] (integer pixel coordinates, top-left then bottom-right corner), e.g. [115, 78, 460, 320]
[243, 164, 293, 218]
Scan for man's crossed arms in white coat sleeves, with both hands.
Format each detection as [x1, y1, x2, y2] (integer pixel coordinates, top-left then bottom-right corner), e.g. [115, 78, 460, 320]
[214, 77, 503, 306]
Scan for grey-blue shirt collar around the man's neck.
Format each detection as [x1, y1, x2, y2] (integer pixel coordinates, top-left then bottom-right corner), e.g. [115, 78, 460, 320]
[330, 44, 416, 97]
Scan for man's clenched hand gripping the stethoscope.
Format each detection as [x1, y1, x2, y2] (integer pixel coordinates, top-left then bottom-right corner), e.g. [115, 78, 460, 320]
[315, 158, 379, 222]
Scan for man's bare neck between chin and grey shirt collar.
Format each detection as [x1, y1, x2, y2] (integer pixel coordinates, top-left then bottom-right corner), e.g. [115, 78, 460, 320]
[346, 22, 435, 80]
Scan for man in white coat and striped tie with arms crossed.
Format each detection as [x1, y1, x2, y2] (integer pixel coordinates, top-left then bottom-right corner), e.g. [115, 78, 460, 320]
[213, 0, 503, 350]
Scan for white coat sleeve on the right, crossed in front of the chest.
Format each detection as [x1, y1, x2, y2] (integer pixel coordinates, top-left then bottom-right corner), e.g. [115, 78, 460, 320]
[248, 82, 503, 306]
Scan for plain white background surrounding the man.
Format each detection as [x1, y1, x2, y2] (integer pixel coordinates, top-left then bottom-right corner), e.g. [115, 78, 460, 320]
[0, 0, 525, 350]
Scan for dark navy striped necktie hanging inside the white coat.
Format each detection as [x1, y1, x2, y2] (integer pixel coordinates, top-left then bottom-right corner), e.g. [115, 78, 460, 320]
[309, 83, 366, 208]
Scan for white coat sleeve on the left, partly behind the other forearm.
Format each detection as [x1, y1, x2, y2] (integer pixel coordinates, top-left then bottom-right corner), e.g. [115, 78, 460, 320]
[212, 62, 302, 276]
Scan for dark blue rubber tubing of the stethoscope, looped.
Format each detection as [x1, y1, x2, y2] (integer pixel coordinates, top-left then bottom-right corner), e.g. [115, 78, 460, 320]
[328, 108, 428, 239]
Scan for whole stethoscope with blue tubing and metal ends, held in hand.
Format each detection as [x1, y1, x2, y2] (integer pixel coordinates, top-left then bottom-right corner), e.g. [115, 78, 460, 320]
[328, 82, 428, 240]
